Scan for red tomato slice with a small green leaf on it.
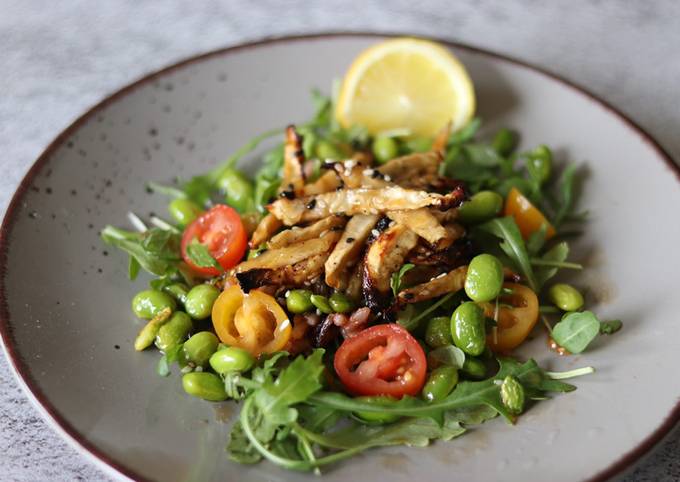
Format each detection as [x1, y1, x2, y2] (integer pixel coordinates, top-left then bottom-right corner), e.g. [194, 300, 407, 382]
[182, 204, 248, 276]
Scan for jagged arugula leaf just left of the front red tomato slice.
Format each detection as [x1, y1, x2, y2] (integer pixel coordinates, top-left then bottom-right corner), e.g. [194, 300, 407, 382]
[253, 349, 324, 425]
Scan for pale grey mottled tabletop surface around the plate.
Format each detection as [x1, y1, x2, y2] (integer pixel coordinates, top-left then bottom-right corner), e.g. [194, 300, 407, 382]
[0, 0, 680, 481]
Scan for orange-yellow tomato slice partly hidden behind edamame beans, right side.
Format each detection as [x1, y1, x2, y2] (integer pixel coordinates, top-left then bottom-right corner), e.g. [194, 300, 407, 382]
[479, 283, 538, 352]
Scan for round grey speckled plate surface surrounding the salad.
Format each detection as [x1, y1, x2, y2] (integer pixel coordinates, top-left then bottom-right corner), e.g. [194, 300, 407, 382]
[0, 34, 680, 482]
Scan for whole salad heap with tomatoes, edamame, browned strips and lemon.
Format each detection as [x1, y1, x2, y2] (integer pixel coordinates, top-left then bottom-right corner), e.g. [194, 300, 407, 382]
[101, 39, 621, 472]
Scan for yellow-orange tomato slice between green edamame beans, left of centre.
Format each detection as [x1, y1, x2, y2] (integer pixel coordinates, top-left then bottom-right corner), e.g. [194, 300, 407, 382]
[212, 285, 292, 356]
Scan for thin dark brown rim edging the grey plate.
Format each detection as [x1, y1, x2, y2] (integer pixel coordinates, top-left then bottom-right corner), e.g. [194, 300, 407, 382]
[0, 31, 680, 482]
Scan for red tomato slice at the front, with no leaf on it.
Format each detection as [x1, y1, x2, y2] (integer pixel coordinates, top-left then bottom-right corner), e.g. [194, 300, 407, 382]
[333, 323, 427, 398]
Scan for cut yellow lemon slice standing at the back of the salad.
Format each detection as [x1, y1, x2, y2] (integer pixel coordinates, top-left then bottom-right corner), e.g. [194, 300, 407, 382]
[335, 38, 475, 137]
